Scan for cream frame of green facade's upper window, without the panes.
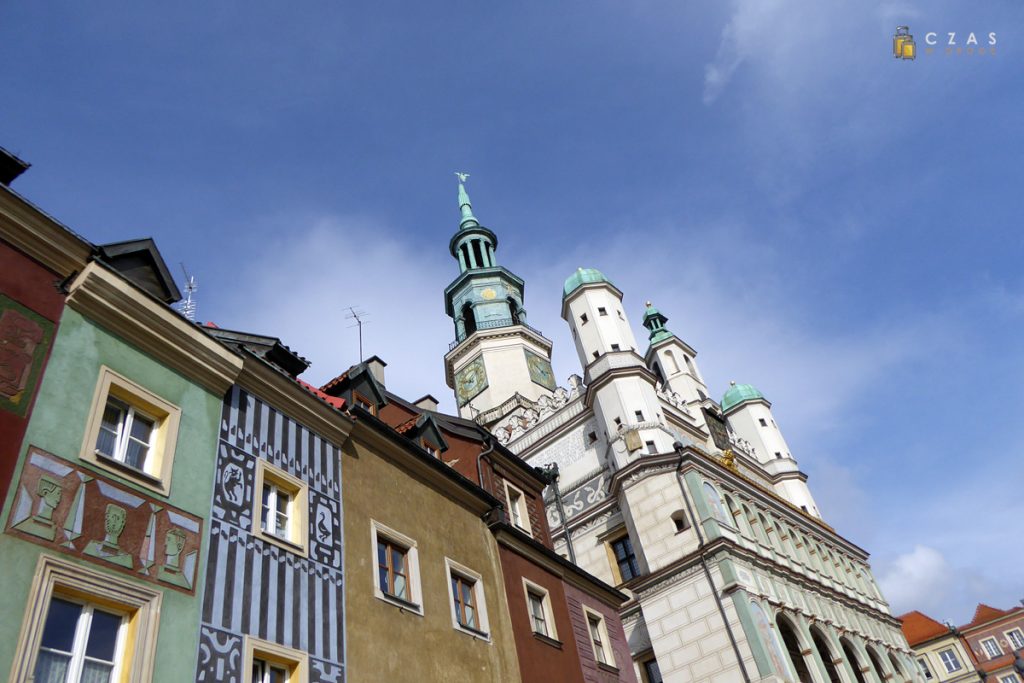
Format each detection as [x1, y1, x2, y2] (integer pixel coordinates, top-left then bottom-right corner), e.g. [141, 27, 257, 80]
[79, 366, 181, 496]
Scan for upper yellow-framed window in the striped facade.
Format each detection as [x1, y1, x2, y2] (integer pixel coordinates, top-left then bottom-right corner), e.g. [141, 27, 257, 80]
[253, 459, 308, 556]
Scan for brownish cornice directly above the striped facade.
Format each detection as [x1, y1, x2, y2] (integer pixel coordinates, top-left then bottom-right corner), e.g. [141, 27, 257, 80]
[238, 355, 352, 447]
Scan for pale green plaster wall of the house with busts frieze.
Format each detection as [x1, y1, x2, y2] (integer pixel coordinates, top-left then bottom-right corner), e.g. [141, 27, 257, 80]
[0, 308, 222, 682]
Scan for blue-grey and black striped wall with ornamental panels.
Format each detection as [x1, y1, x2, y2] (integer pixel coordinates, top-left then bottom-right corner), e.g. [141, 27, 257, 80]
[196, 386, 345, 683]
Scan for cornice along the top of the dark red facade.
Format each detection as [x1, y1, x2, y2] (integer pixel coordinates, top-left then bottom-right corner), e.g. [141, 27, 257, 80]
[0, 187, 92, 278]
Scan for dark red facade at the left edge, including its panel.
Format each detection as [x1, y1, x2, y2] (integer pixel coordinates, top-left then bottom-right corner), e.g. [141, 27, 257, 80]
[0, 241, 65, 500]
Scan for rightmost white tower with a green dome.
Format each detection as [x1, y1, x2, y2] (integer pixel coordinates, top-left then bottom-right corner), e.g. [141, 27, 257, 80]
[722, 382, 821, 518]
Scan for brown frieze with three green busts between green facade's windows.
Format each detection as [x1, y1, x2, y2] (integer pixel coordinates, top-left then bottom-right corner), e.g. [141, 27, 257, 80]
[7, 446, 203, 594]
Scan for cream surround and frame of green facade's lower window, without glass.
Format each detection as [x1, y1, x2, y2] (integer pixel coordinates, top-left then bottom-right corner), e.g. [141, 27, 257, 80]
[9, 554, 163, 683]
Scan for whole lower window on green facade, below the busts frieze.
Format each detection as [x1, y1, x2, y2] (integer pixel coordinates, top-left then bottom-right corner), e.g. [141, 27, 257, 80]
[10, 555, 162, 683]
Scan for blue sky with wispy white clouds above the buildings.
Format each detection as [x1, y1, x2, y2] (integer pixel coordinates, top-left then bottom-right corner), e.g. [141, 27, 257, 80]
[0, 0, 1024, 622]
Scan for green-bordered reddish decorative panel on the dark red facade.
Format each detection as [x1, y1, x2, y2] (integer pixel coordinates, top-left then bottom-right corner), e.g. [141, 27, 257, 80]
[0, 294, 53, 417]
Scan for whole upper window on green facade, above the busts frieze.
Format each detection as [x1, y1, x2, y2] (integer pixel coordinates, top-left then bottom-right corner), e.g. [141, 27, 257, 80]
[80, 367, 181, 496]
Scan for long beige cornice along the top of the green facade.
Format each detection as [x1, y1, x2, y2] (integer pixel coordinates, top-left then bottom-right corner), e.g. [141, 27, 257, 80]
[68, 261, 242, 397]
